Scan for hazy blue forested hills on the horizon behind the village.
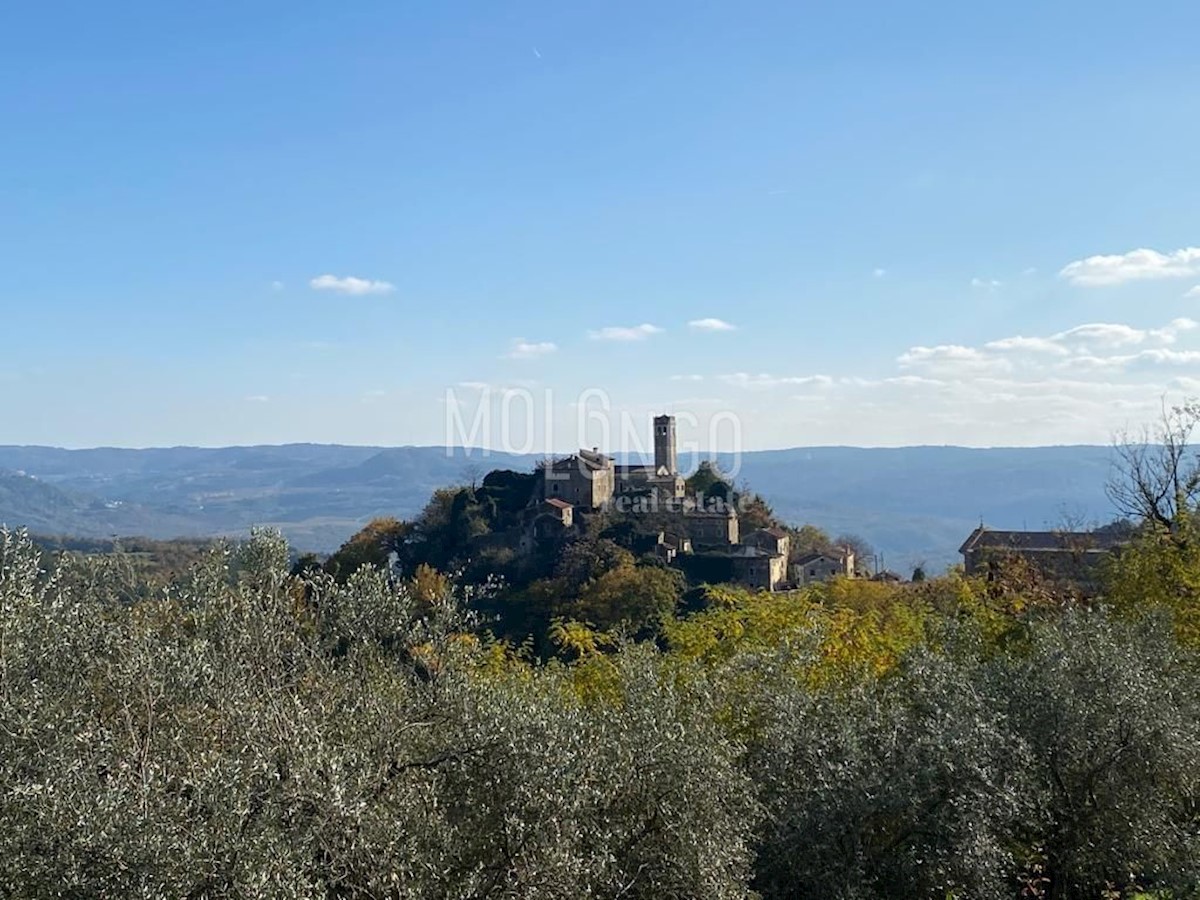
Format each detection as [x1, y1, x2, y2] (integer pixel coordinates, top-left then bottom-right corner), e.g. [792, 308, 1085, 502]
[0, 444, 1111, 570]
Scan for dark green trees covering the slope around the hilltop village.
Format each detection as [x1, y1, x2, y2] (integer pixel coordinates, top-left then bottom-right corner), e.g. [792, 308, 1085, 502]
[314, 462, 872, 659]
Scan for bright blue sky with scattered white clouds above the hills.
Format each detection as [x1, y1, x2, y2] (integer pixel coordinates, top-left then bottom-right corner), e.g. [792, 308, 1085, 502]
[0, 1, 1200, 449]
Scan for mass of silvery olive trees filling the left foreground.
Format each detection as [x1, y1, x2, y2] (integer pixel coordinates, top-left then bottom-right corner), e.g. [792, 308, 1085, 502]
[0, 534, 756, 900]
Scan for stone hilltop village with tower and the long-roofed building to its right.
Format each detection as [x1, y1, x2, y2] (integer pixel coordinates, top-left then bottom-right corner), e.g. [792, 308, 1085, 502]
[426, 415, 1121, 600]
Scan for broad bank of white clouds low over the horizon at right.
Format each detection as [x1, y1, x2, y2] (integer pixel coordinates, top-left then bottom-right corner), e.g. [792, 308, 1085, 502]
[578, 316, 1200, 446]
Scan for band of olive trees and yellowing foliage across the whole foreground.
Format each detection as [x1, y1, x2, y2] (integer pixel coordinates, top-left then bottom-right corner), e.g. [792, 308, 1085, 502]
[7, 410, 1200, 900]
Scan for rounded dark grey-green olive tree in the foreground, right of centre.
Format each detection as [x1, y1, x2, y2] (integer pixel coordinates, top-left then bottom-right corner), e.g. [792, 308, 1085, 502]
[748, 653, 1028, 898]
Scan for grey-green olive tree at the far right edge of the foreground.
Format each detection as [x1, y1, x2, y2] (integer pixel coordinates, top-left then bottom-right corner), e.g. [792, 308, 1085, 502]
[1001, 611, 1200, 898]
